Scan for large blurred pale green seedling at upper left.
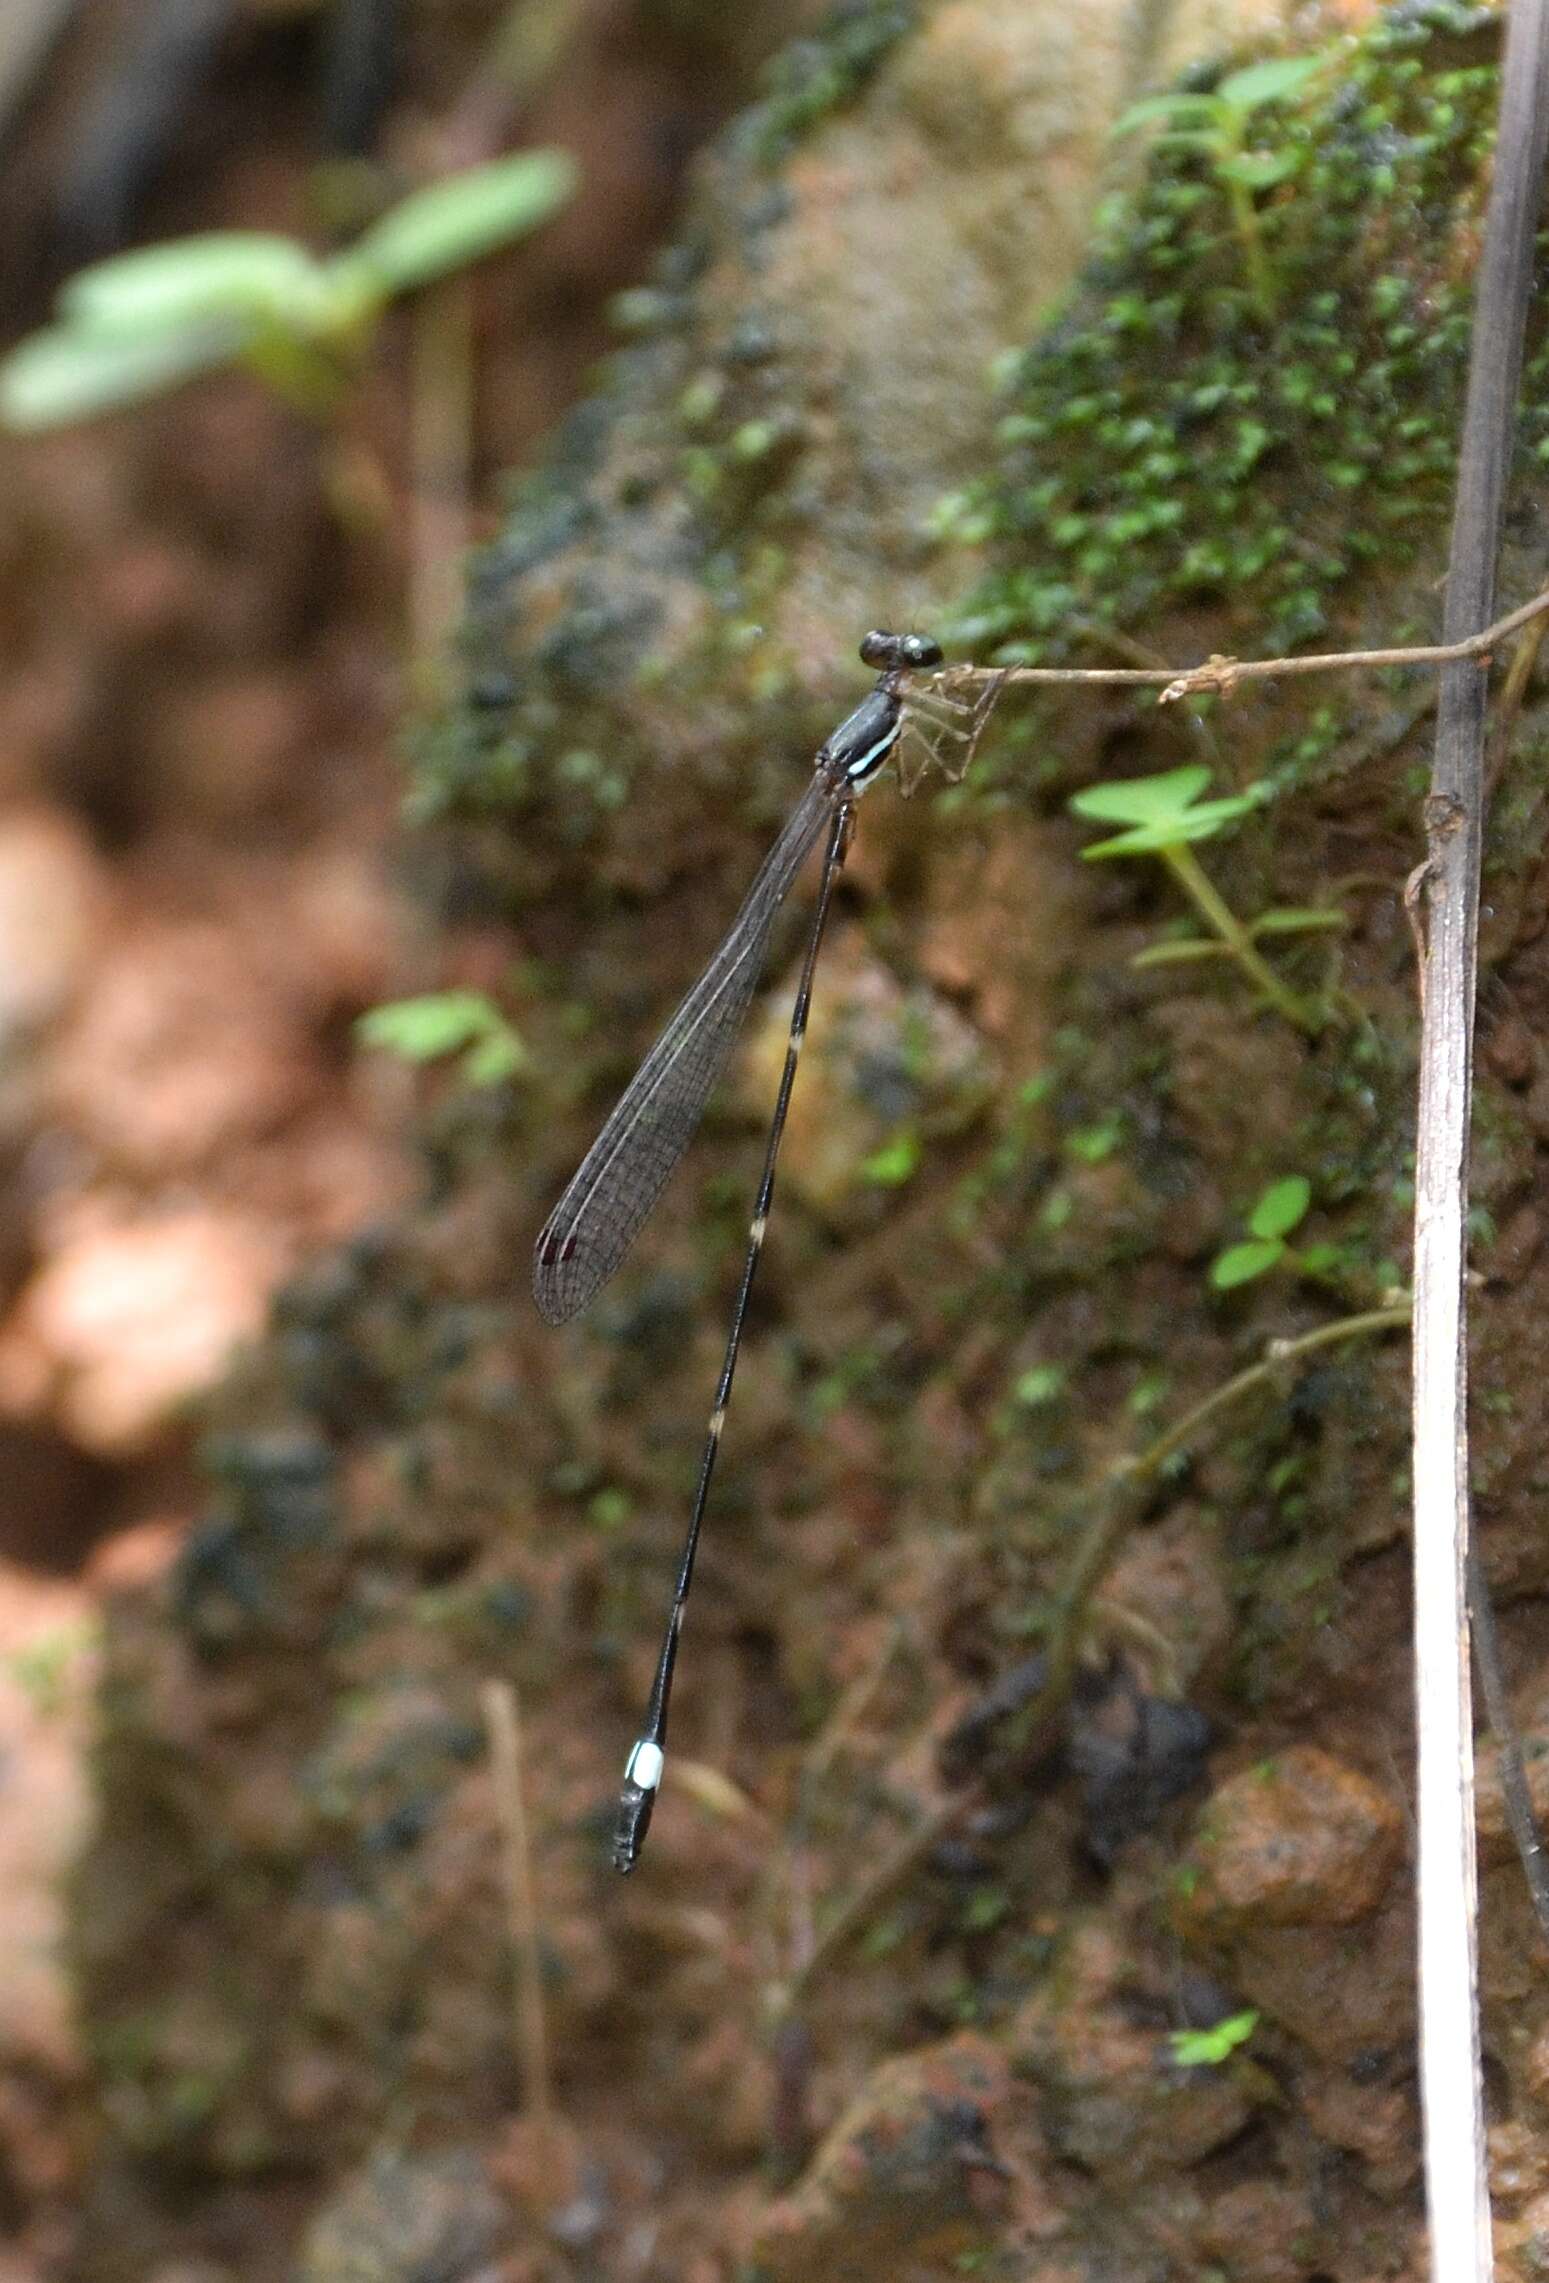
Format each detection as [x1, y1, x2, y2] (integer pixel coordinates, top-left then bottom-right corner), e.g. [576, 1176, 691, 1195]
[0, 151, 576, 431]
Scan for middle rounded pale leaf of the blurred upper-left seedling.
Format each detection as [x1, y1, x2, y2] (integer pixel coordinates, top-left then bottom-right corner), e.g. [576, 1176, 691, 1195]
[59, 231, 324, 340]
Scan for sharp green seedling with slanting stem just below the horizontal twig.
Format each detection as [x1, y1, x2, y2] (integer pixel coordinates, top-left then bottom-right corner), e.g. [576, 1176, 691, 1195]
[1069, 763, 1343, 1036]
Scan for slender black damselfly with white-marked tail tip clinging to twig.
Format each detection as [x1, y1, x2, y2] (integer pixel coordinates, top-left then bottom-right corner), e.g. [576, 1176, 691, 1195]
[532, 632, 998, 1872]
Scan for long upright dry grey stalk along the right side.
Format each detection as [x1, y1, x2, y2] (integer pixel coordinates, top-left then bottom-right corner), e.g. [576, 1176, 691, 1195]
[1412, 0, 1549, 2283]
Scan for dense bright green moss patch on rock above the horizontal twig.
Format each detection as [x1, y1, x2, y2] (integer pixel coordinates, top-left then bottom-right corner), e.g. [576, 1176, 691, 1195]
[941, 5, 1507, 757]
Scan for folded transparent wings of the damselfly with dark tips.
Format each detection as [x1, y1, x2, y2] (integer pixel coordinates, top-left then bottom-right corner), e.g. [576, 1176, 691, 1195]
[532, 776, 841, 1324]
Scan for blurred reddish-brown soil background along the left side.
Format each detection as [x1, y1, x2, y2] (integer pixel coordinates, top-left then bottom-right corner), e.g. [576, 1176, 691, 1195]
[0, 0, 827, 2278]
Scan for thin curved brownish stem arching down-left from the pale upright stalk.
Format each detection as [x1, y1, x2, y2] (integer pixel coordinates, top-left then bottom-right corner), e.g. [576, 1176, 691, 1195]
[772, 1304, 1410, 2018]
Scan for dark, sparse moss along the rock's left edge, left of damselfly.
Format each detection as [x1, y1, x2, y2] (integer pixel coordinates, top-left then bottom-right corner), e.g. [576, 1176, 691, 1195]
[409, 0, 921, 840]
